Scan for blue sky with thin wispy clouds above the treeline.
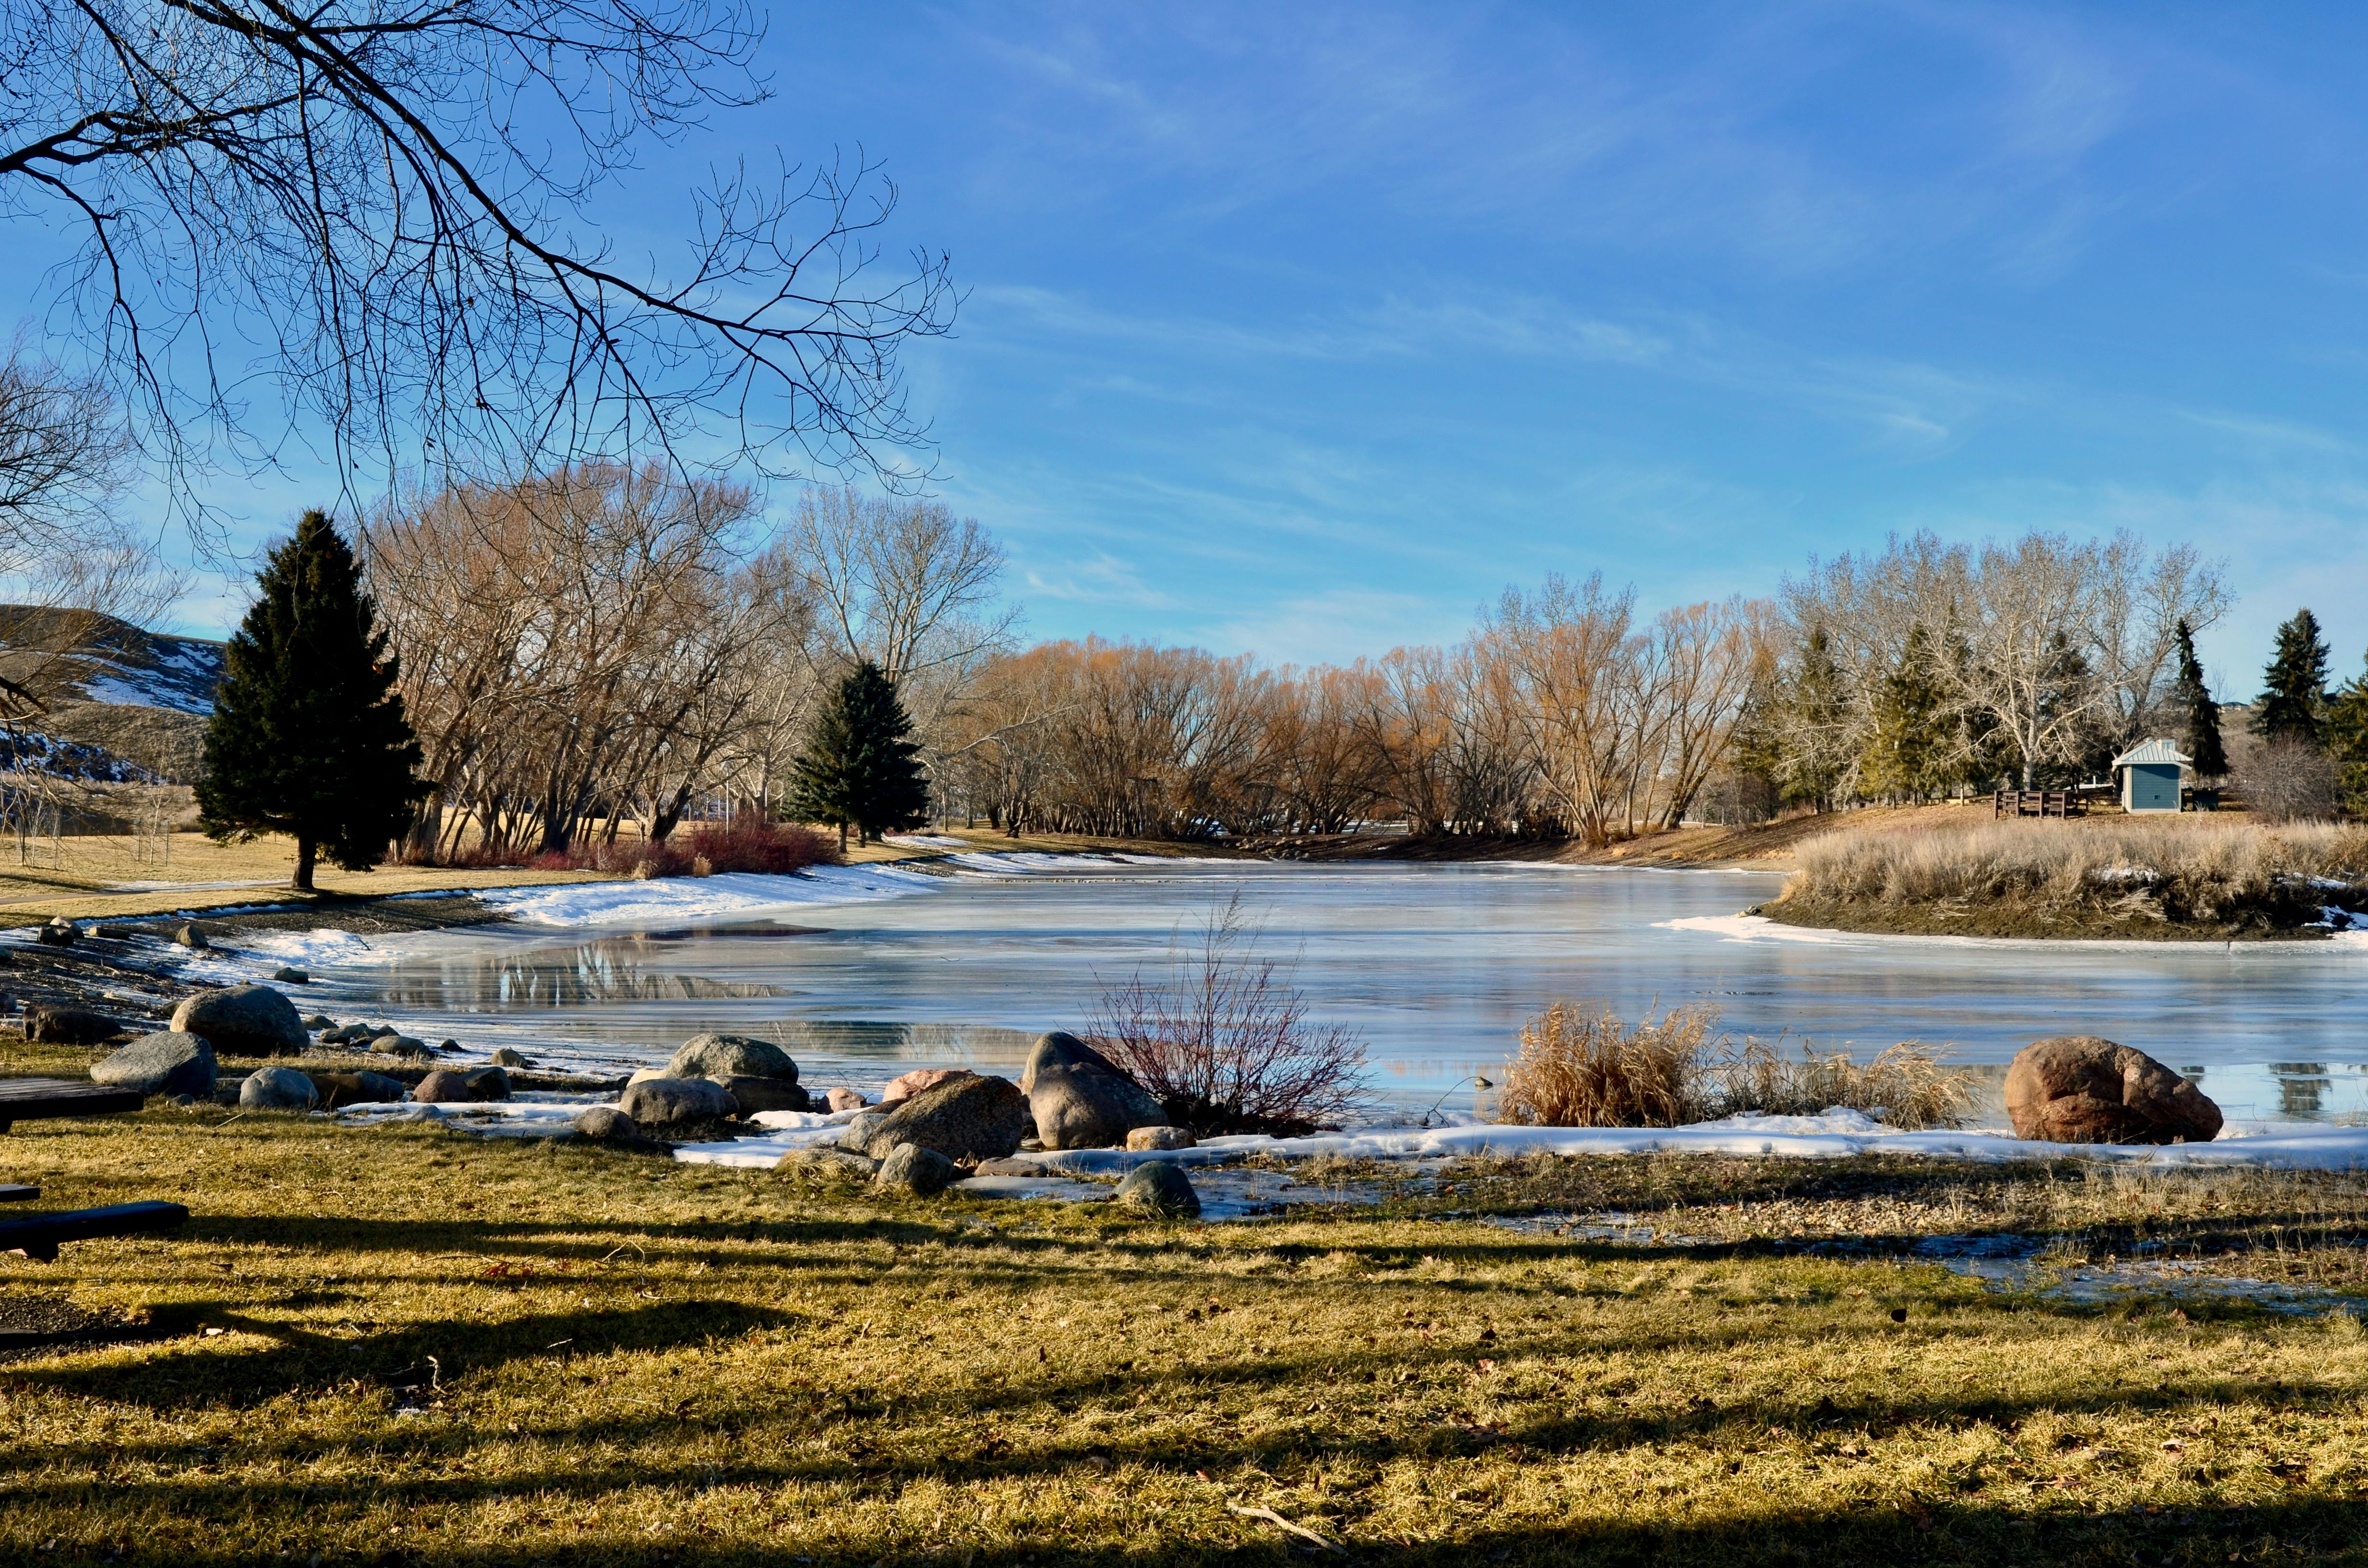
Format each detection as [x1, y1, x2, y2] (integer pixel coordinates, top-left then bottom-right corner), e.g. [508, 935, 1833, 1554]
[23, 2, 2368, 697]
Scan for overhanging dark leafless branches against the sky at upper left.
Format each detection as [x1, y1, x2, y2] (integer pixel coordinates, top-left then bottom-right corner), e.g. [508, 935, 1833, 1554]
[0, 0, 952, 528]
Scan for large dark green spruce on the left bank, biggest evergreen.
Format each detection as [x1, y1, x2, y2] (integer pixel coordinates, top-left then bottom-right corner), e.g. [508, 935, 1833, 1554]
[197, 512, 426, 893]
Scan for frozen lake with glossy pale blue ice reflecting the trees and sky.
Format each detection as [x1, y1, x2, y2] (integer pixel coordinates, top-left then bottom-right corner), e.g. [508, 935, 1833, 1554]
[320, 858, 2368, 1118]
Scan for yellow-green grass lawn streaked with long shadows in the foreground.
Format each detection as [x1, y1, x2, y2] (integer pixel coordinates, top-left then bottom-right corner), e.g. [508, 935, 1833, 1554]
[0, 1103, 2368, 1568]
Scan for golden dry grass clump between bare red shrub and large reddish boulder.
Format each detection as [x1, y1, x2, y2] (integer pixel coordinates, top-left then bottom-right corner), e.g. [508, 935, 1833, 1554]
[1499, 1002, 1975, 1127]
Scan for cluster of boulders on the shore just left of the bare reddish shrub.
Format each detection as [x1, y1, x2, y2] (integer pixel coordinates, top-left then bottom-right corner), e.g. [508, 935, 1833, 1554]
[781, 1033, 1200, 1217]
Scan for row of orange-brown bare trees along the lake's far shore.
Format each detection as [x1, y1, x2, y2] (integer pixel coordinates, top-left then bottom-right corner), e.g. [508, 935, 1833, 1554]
[933, 578, 1771, 843]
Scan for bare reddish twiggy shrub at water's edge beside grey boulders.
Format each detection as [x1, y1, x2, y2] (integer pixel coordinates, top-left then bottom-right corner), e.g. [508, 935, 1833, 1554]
[1087, 893, 1364, 1137]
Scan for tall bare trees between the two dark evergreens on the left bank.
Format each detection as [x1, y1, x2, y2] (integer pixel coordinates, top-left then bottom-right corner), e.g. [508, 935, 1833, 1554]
[362, 462, 1006, 858]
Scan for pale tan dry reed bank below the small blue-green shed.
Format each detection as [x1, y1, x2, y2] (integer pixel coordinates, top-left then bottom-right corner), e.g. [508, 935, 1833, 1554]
[1783, 817, 2368, 921]
